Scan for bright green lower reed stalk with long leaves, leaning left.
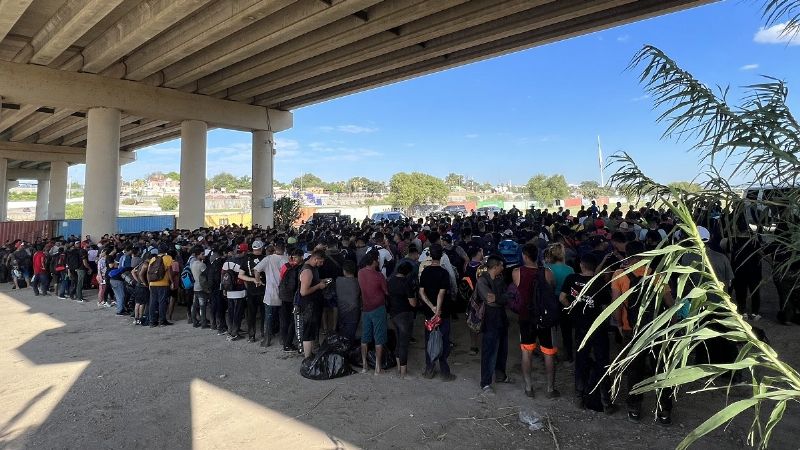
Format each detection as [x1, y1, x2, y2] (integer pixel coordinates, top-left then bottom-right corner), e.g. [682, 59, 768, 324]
[581, 154, 800, 448]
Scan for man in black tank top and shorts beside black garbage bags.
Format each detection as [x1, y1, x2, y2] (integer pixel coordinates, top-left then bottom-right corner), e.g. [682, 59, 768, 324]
[299, 250, 332, 358]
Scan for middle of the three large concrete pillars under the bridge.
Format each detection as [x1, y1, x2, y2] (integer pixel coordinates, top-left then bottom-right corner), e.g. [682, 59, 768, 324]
[178, 120, 208, 230]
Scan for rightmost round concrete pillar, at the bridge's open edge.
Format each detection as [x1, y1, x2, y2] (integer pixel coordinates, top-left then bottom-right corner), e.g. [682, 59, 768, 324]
[252, 131, 275, 227]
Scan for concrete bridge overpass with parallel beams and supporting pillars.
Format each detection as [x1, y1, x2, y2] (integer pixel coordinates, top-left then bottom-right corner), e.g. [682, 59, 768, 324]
[0, 0, 713, 237]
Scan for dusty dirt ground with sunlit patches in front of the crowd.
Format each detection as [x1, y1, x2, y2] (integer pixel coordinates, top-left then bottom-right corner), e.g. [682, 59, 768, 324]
[0, 276, 800, 449]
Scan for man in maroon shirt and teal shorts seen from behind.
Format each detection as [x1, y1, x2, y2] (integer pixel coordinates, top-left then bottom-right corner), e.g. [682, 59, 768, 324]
[358, 250, 389, 375]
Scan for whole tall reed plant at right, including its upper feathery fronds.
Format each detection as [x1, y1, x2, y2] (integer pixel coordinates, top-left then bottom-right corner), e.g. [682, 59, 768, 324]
[581, 26, 800, 448]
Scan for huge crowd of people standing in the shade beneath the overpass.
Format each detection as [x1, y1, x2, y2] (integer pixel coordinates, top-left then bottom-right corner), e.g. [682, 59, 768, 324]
[0, 202, 798, 425]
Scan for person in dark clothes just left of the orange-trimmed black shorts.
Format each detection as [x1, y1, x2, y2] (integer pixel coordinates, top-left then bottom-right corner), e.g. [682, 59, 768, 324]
[475, 256, 512, 393]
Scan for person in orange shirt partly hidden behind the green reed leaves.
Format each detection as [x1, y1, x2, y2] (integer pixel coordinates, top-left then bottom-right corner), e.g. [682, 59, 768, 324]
[611, 241, 673, 426]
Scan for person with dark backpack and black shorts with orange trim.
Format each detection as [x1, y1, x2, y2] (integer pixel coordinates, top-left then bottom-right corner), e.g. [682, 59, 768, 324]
[511, 244, 561, 398]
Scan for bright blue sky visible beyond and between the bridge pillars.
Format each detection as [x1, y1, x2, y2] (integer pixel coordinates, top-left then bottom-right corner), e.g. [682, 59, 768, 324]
[70, 0, 800, 183]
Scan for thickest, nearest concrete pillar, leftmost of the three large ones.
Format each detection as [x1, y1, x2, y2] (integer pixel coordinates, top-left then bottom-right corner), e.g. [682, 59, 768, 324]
[81, 108, 120, 241]
